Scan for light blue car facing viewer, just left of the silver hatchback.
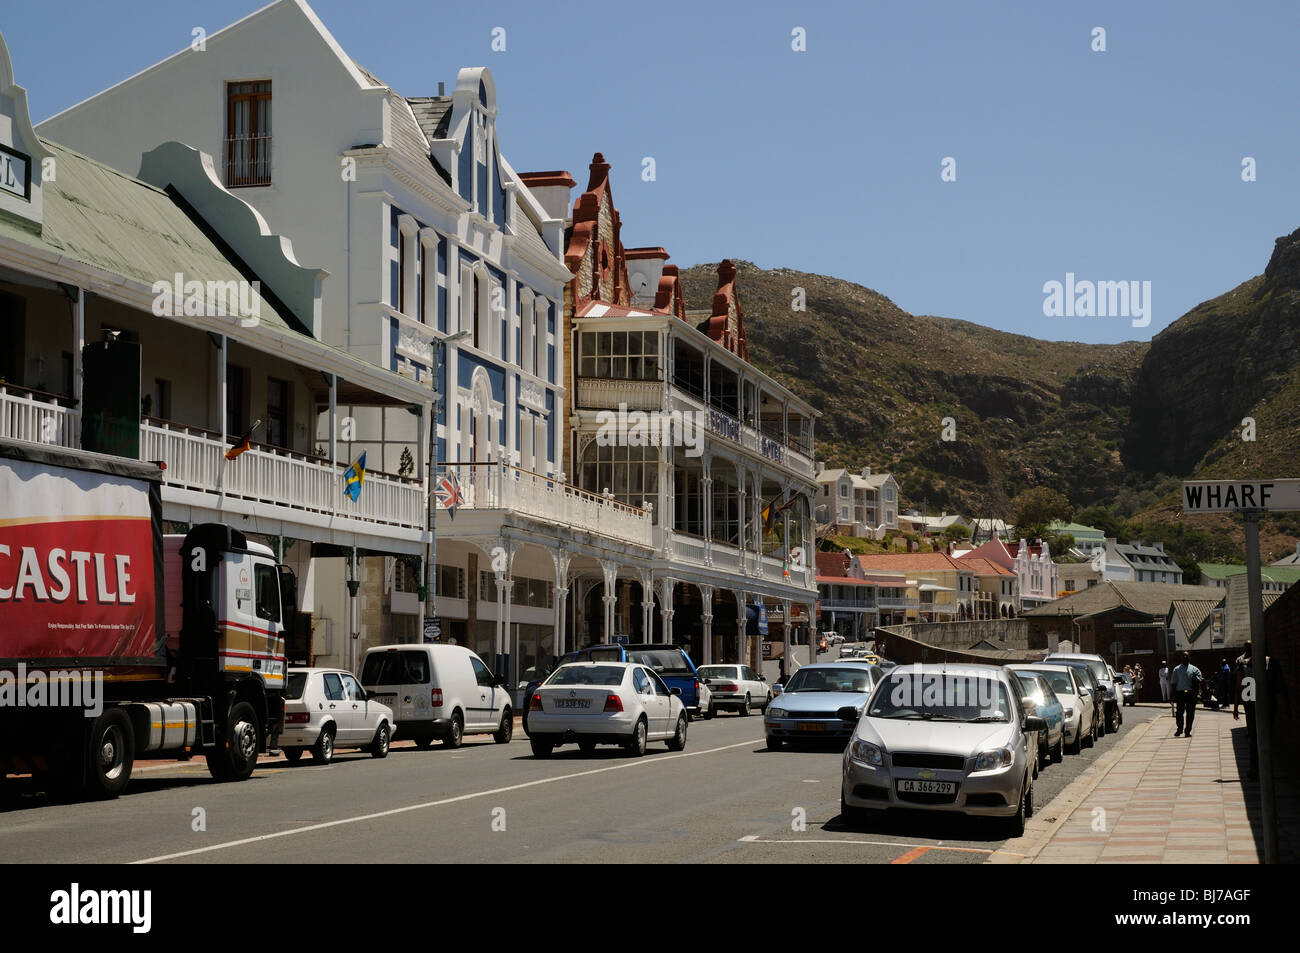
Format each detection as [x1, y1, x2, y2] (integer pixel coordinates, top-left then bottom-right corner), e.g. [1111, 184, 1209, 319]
[763, 662, 880, 751]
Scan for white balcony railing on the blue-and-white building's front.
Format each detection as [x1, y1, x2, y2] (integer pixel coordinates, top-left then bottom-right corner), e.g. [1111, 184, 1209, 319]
[445, 462, 654, 547]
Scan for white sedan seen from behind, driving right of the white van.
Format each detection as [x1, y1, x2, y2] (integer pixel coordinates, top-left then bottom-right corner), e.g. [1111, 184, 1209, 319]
[528, 662, 688, 758]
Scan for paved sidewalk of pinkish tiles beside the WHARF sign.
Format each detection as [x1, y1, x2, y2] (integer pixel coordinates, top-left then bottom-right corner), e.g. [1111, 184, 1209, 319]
[1031, 709, 1300, 863]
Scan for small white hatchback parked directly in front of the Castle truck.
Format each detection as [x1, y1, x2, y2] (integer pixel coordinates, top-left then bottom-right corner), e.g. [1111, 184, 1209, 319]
[280, 668, 393, 764]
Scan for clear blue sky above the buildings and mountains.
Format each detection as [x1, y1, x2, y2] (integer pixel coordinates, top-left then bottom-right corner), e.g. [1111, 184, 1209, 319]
[10, 0, 1300, 342]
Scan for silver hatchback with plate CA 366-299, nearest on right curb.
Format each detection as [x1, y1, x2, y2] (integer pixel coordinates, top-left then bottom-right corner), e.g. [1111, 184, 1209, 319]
[840, 664, 1047, 836]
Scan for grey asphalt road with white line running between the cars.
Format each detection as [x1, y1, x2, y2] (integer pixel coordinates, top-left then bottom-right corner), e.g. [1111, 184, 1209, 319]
[0, 686, 1160, 863]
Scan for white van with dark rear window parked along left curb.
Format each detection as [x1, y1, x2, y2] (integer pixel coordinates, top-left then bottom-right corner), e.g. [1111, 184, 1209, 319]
[361, 644, 515, 748]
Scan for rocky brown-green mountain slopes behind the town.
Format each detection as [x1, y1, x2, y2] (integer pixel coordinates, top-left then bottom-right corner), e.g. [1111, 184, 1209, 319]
[681, 230, 1300, 530]
